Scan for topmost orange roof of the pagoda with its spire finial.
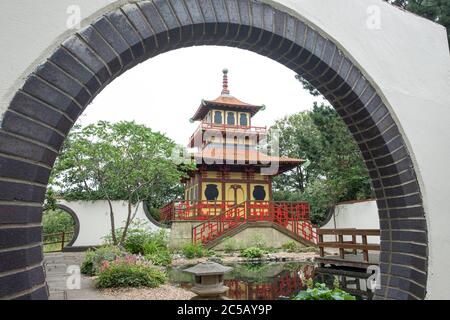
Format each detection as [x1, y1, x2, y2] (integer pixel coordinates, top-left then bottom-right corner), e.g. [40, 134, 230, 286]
[192, 69, 264, 121]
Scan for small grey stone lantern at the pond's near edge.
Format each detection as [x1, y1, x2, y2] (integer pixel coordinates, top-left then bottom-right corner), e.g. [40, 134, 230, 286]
[184, 261, 233, 299]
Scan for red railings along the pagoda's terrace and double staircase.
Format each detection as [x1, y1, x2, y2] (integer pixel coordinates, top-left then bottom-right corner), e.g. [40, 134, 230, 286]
[160, 201, 317, 247]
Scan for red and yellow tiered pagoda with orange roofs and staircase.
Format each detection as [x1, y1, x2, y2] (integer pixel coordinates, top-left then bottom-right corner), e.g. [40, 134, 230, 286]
[160, 69, 315, 247]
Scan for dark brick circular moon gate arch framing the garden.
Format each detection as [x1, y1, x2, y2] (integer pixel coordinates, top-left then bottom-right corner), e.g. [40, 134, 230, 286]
[0, 0, 428, 299]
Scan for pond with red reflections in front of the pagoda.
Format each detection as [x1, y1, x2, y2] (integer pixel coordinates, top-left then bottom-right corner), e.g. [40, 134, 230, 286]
[169, 262, 371, 300]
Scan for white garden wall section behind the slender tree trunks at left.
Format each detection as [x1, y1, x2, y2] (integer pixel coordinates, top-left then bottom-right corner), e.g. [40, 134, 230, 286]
[58, 200, 159, 247]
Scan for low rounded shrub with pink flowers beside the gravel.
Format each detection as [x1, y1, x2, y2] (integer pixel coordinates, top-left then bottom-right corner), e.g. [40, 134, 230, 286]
[96, 256, 167, 288]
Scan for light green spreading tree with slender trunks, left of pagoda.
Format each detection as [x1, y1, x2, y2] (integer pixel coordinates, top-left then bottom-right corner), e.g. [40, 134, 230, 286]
[51, 121, 192, 244]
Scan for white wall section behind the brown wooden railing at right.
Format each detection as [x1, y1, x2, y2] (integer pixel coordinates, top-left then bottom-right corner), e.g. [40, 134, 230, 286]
[322, 200, 380, 243]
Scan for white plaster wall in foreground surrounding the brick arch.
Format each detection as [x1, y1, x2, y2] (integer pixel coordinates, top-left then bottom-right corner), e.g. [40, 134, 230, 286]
[0, 0, 450, 298]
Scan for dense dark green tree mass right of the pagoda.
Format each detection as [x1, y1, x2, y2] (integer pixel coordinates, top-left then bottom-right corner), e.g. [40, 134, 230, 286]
[274, 103, 372, 222]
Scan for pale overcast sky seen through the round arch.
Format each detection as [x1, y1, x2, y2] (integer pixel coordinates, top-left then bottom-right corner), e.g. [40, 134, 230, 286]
[79, 46, 323, 145]
